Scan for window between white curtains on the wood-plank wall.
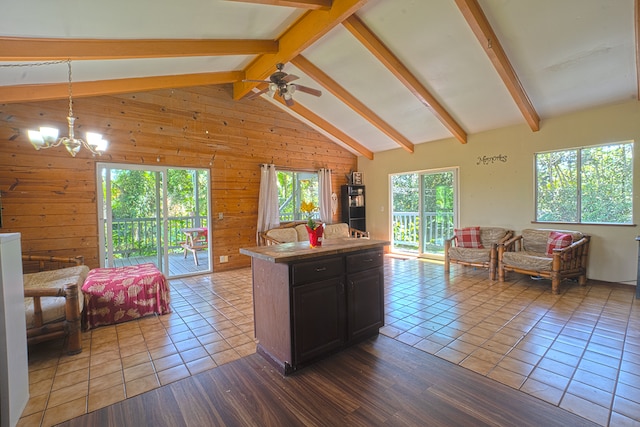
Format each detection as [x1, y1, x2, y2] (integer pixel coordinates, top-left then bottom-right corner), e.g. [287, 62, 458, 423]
[278, 171, 320, 222]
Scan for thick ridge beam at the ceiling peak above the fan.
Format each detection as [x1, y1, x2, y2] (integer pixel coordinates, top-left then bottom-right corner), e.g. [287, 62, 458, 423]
[233, 0, 367, 99]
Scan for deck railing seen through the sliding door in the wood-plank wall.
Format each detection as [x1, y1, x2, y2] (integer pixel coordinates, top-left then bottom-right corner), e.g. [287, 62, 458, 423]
[105, 216, 207, 258]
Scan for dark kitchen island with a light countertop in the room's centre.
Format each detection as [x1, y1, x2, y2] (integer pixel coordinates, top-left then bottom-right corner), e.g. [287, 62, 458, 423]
[240, 239, 389, 375]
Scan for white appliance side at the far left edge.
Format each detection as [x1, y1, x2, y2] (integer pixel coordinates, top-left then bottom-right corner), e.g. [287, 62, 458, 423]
[0, 233, 29, 427]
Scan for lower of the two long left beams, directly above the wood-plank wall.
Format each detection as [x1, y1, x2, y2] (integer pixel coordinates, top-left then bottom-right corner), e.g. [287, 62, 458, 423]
[0, 71, 244, 104]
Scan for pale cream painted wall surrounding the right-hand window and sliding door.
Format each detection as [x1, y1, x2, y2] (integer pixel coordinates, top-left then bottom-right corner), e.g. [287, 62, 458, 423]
[358, 101, 640, 284]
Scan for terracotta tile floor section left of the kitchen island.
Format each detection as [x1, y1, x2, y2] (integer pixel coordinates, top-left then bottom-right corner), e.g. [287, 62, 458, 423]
[18, 269, 256, 426]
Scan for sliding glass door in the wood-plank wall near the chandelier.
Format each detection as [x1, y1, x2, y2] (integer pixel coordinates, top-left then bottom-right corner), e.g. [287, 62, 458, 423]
[98, 163, 211, 277]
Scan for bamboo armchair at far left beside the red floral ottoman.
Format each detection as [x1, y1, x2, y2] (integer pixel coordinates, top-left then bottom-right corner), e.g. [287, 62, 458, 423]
[22, 255, 89, 354]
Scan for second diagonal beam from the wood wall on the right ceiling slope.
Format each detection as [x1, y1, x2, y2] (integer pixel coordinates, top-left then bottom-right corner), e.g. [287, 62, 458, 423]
[291, 55, 414, 153]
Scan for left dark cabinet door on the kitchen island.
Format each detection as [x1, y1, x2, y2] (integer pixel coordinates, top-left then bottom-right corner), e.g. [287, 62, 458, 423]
[293, 276, 346, 365]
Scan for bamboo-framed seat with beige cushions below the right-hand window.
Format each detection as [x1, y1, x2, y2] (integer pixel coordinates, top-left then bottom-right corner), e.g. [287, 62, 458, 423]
[498, 229, 591, 294]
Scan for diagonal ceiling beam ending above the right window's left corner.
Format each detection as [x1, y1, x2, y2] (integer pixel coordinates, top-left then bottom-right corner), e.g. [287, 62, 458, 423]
[455, 0, 540, 132]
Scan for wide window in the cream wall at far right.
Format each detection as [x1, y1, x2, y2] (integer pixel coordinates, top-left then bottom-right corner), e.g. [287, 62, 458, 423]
[535, 142, 633, 224]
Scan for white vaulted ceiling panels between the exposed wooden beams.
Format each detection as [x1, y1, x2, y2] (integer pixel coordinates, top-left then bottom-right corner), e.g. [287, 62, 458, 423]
[0, 0, 638, 157]
